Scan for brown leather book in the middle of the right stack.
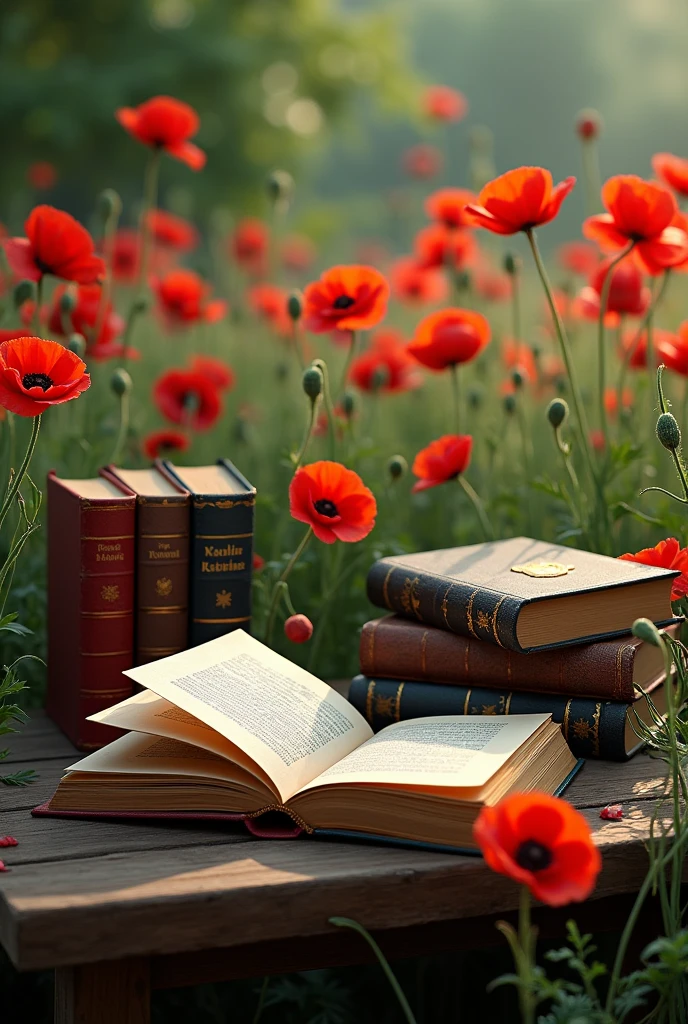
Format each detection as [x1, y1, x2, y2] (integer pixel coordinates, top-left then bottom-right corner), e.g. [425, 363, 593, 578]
[360, 615, 679, 701]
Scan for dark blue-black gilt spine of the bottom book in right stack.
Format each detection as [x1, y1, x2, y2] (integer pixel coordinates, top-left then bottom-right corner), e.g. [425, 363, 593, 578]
[349, 676, 629, 761]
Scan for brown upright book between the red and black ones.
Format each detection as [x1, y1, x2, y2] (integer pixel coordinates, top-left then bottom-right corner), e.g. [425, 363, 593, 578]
[103, 466, 190, 665]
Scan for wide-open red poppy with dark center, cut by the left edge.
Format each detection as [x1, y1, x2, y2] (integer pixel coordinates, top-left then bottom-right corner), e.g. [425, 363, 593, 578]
[0, 337, 91, 416]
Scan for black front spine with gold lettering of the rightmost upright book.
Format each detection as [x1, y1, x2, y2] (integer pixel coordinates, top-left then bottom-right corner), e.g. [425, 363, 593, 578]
[188, 494, 256, 647]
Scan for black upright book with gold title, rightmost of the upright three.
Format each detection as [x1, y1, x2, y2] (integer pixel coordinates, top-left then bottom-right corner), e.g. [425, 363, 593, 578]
[159, 459, 256, 647]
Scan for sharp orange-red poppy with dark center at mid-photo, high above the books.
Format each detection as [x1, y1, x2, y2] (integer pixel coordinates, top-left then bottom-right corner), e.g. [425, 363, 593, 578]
[303, 265, 389, 334]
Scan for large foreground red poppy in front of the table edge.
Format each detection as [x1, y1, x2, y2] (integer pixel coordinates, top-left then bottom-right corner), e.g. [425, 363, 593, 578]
[473, 793, 602, 906]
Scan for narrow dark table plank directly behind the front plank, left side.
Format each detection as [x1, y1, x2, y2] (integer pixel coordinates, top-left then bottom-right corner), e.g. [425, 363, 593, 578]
[0, 811, 251, 874]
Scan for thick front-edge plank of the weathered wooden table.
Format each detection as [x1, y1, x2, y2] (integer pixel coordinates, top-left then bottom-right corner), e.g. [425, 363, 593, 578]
[0, 803, 667, 969]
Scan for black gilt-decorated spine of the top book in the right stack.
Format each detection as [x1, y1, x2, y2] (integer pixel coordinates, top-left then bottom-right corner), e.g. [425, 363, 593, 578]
[368, 558, 523, 651]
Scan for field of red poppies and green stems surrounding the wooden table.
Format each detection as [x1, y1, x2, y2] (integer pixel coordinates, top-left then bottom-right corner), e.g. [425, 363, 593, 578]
[5, 18, 688, 1024]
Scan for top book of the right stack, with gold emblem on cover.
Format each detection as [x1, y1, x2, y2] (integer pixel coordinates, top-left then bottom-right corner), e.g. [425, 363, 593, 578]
[368, 537, 678, 652]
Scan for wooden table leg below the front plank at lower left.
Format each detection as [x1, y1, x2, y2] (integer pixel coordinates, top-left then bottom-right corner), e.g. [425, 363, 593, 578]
[55, 957, 151, 1024]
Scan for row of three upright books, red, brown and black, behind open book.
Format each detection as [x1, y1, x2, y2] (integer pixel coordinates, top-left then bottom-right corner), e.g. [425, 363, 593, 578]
[46, 459, 256, 750]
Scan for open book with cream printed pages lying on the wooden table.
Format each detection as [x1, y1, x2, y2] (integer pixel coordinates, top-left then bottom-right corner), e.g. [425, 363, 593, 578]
[40, 630, 577, 848]
